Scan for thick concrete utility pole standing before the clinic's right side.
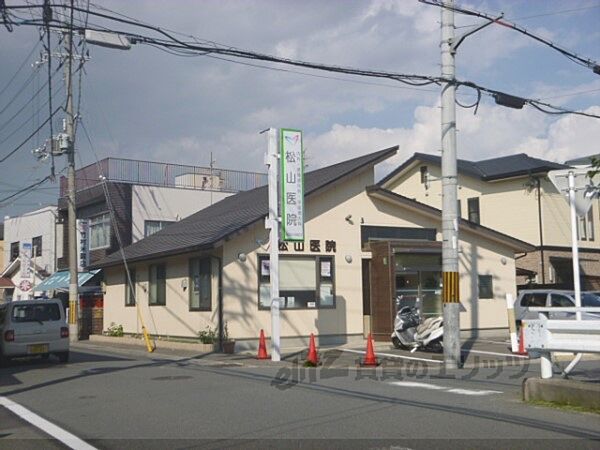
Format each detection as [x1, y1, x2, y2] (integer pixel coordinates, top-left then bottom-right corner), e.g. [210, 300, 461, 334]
[441, 0, 461, 369]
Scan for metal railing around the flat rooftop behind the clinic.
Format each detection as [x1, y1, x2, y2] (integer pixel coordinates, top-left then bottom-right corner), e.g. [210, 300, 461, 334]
[60, 158, 267, 197]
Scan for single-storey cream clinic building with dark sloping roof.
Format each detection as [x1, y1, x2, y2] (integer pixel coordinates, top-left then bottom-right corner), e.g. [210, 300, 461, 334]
[92, 147, 533, 348]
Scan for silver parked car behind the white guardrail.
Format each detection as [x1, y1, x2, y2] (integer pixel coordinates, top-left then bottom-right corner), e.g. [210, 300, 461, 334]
[515, 289, 600, 324]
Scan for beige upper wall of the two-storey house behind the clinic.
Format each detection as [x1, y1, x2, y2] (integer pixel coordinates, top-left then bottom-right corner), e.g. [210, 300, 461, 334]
[387, 164, 600, 248]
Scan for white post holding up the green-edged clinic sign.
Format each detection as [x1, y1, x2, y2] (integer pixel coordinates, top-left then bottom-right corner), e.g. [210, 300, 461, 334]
[266, 128, 281, 361]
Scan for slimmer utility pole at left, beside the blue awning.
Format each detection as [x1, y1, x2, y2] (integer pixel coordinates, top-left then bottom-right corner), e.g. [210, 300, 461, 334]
[64, 1, 79, 341]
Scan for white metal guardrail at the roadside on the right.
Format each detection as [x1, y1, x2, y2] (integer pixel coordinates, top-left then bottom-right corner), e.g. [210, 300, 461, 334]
[522, 307, 600, 378]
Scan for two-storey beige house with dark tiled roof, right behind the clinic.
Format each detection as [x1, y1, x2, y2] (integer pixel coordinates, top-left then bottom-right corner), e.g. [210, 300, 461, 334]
[381, 153, 600, 289]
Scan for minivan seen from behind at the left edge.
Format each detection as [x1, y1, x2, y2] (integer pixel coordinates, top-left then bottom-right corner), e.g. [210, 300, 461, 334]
[0, 299, 69, 364]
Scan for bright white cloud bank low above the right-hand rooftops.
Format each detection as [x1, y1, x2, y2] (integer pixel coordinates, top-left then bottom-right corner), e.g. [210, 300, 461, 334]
[306, 104, 600, 178]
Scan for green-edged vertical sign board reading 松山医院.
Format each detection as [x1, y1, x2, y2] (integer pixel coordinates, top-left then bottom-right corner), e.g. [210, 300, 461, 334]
[280, 128, 304, 241]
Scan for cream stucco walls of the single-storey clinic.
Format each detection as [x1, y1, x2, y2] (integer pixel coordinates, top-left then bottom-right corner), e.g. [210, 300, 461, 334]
[104, 165, 515, 339]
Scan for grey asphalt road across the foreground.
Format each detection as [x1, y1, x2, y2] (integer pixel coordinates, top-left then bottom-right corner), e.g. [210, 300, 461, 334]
[0, 344, 600, 449]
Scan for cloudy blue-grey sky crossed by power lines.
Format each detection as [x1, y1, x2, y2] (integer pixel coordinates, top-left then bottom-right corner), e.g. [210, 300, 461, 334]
[0, 0, 600, 217]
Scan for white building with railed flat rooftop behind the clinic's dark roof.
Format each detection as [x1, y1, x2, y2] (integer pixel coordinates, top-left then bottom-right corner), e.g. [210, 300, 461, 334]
[58, 158, 266, 270]
